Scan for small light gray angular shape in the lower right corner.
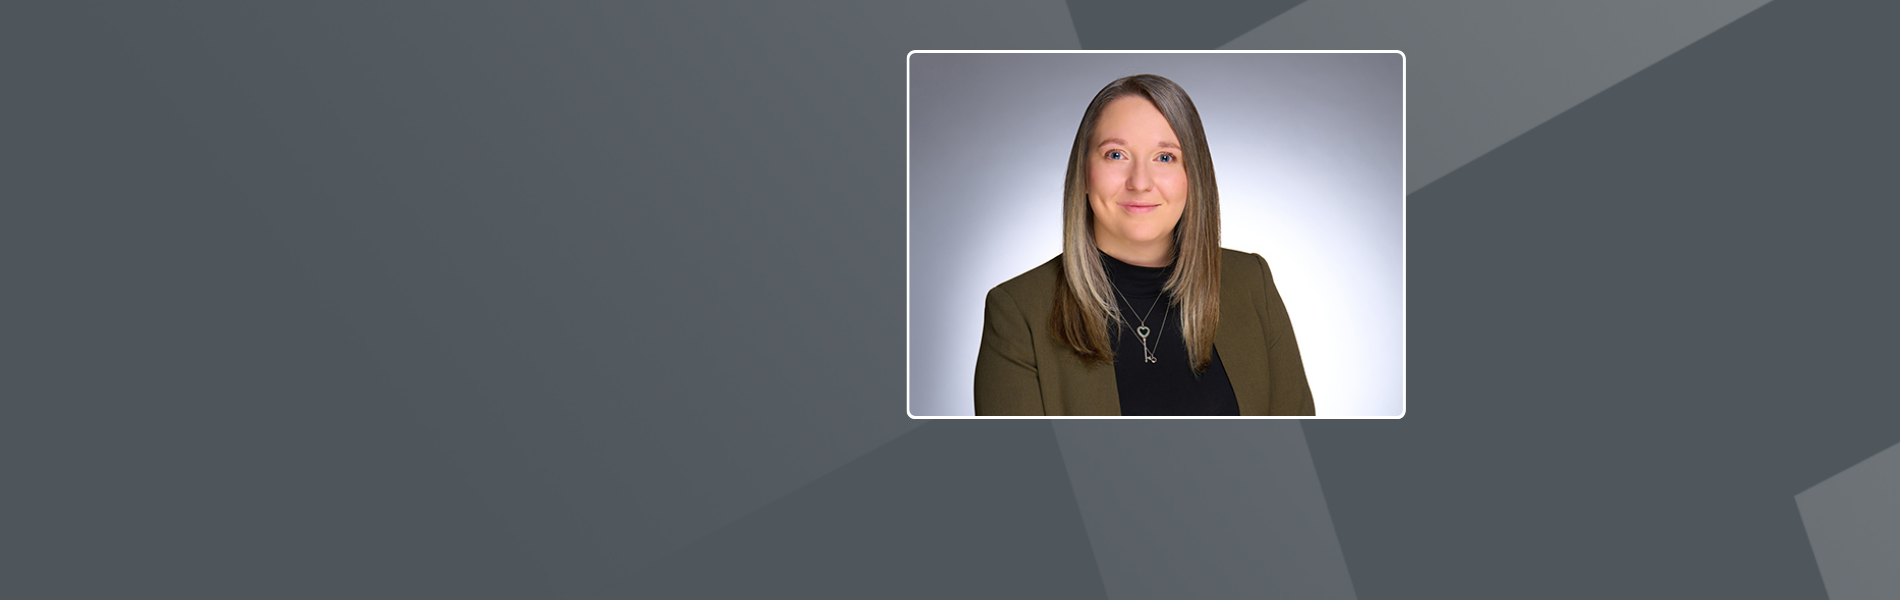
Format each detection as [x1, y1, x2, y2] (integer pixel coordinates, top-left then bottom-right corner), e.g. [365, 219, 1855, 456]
[1793, 444, 1900, 600]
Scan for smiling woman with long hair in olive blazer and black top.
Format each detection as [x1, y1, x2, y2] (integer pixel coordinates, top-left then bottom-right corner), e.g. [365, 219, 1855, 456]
[977, 74, 1313, 416]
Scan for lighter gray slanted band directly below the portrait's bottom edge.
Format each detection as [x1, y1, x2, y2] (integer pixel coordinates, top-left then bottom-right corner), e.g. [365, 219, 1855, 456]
[1055, 420, 1357, 600]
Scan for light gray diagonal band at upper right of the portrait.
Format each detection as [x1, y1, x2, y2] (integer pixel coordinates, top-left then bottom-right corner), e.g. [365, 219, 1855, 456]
[1222, 0, 1767, 194]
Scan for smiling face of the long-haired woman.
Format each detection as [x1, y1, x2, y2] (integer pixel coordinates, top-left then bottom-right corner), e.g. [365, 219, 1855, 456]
[1089, 97, 1188, 264]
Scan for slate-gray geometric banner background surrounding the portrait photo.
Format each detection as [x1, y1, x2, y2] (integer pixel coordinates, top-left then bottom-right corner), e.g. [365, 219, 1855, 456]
[11, 0, 1900, 598]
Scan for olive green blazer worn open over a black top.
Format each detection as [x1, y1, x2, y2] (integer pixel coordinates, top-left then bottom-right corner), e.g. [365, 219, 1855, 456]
[977, 249, 1313, 416]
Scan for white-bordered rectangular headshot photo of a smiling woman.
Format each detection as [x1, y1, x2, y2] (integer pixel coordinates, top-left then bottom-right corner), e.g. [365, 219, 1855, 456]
[906, 51, 1406, 418]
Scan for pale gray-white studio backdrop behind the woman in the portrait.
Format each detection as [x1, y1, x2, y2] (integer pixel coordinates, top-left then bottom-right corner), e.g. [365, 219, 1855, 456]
[910, 53, 1404, 416]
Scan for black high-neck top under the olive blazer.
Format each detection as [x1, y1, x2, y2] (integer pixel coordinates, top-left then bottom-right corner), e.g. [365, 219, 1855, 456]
[1102, 254, 1241, 416]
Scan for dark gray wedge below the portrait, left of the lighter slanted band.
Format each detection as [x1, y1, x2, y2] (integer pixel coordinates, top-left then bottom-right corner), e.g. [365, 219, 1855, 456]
[637, 420, 1106, 600]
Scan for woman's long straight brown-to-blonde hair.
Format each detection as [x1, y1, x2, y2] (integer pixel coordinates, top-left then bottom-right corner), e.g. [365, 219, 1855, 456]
[1049, 74, 1220, 372]
